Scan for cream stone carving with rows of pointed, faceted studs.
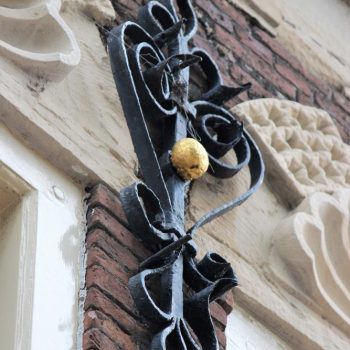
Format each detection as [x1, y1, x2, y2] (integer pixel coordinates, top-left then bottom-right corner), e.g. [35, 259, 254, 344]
[233, 99, 350, 207]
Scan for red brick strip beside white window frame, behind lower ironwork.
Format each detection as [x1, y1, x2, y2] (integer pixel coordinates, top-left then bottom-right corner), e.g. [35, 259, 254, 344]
[83, 185, 233, 350]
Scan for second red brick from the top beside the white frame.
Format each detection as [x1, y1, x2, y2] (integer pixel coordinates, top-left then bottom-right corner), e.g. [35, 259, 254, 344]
[87, 208, 152, 259]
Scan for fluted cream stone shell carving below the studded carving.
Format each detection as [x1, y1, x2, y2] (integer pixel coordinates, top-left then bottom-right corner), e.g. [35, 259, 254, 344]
[268, 190, 350, 334]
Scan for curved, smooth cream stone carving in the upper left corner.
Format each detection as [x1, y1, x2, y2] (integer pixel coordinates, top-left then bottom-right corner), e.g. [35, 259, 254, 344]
[0, 0, 80, 80]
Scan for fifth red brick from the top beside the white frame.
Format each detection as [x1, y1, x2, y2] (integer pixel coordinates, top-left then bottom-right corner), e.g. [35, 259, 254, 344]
[85, 267, 138, 315]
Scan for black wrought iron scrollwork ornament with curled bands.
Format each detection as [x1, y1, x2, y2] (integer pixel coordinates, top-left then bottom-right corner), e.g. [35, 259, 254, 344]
[108, 0, 264, 350]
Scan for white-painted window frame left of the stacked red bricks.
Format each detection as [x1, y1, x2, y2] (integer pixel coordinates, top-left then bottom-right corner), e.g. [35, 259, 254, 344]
[0, 124, 85, 350]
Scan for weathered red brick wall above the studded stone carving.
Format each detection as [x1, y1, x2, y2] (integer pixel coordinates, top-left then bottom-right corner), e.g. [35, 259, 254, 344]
[111, 0, 350, 143]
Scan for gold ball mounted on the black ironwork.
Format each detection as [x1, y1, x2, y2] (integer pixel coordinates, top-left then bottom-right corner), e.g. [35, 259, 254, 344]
[171, 138, 209, 181]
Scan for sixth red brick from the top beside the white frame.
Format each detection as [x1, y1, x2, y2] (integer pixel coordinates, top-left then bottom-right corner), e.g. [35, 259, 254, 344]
[84, 288, 148, 337]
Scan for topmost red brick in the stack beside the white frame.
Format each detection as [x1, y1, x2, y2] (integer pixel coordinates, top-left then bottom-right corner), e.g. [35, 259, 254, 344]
[88, 184, 128, 225]
